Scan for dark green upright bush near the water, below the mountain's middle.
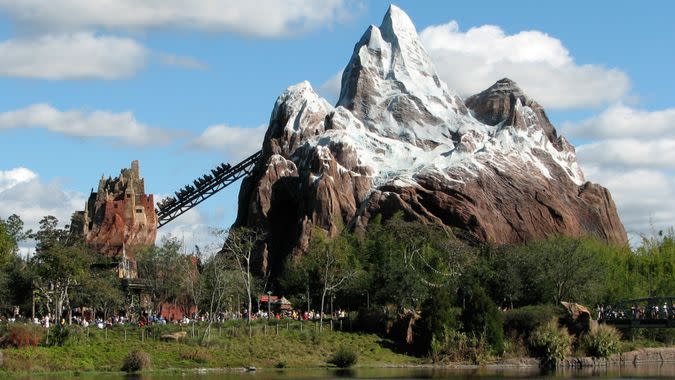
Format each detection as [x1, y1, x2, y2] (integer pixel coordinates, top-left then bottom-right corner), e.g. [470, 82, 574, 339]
[460, 286, 504, 354]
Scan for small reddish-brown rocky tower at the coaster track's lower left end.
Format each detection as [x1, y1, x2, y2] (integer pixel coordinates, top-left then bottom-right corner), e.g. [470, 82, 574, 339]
[72, 161, 157, 269]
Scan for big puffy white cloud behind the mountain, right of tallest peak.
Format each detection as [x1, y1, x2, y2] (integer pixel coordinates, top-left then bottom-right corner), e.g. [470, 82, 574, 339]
[420, 21, 630, 108]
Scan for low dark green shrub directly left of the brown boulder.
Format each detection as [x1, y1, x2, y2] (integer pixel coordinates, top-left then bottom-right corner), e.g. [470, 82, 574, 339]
[504, 305, 562, 340]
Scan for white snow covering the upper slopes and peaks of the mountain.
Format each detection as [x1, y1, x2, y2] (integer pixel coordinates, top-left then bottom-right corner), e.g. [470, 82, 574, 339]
[272, 5, 584, 187]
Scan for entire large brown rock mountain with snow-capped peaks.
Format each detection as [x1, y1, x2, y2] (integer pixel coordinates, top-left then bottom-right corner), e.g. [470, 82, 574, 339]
[234, 6, 627, 271]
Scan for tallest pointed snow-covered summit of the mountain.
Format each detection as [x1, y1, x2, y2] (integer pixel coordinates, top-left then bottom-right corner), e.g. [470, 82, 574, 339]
[337, 5, 468, 150]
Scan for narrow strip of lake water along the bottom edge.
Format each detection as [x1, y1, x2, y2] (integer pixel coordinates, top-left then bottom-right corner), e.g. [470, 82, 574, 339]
[9, 363, 675, 380]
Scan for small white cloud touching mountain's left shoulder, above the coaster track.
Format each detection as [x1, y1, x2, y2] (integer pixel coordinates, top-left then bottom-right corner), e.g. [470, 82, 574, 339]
[188, 125, 267, 159]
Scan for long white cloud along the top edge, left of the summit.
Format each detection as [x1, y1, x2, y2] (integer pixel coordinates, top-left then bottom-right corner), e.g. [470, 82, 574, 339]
[0, 0, 354, 38]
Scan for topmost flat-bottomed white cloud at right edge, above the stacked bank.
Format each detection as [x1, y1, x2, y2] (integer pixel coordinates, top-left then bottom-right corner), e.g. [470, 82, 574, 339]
[562, 104, 675, 138]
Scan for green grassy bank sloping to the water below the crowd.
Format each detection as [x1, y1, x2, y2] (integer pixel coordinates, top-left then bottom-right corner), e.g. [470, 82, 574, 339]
[0, 321, 419, 377]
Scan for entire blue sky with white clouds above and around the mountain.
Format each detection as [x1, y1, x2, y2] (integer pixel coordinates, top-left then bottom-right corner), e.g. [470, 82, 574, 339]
[0, 0, 675, 248]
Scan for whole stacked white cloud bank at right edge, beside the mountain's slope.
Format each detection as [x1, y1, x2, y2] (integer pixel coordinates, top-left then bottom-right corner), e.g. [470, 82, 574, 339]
[563, 105, 675, 235]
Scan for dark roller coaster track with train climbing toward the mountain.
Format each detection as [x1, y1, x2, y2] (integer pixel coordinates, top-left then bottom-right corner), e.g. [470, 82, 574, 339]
[155, 151, 262, 228]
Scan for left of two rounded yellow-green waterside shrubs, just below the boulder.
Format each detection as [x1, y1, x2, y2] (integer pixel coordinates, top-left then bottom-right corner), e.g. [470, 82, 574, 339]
[528, 319, 572, 366]
